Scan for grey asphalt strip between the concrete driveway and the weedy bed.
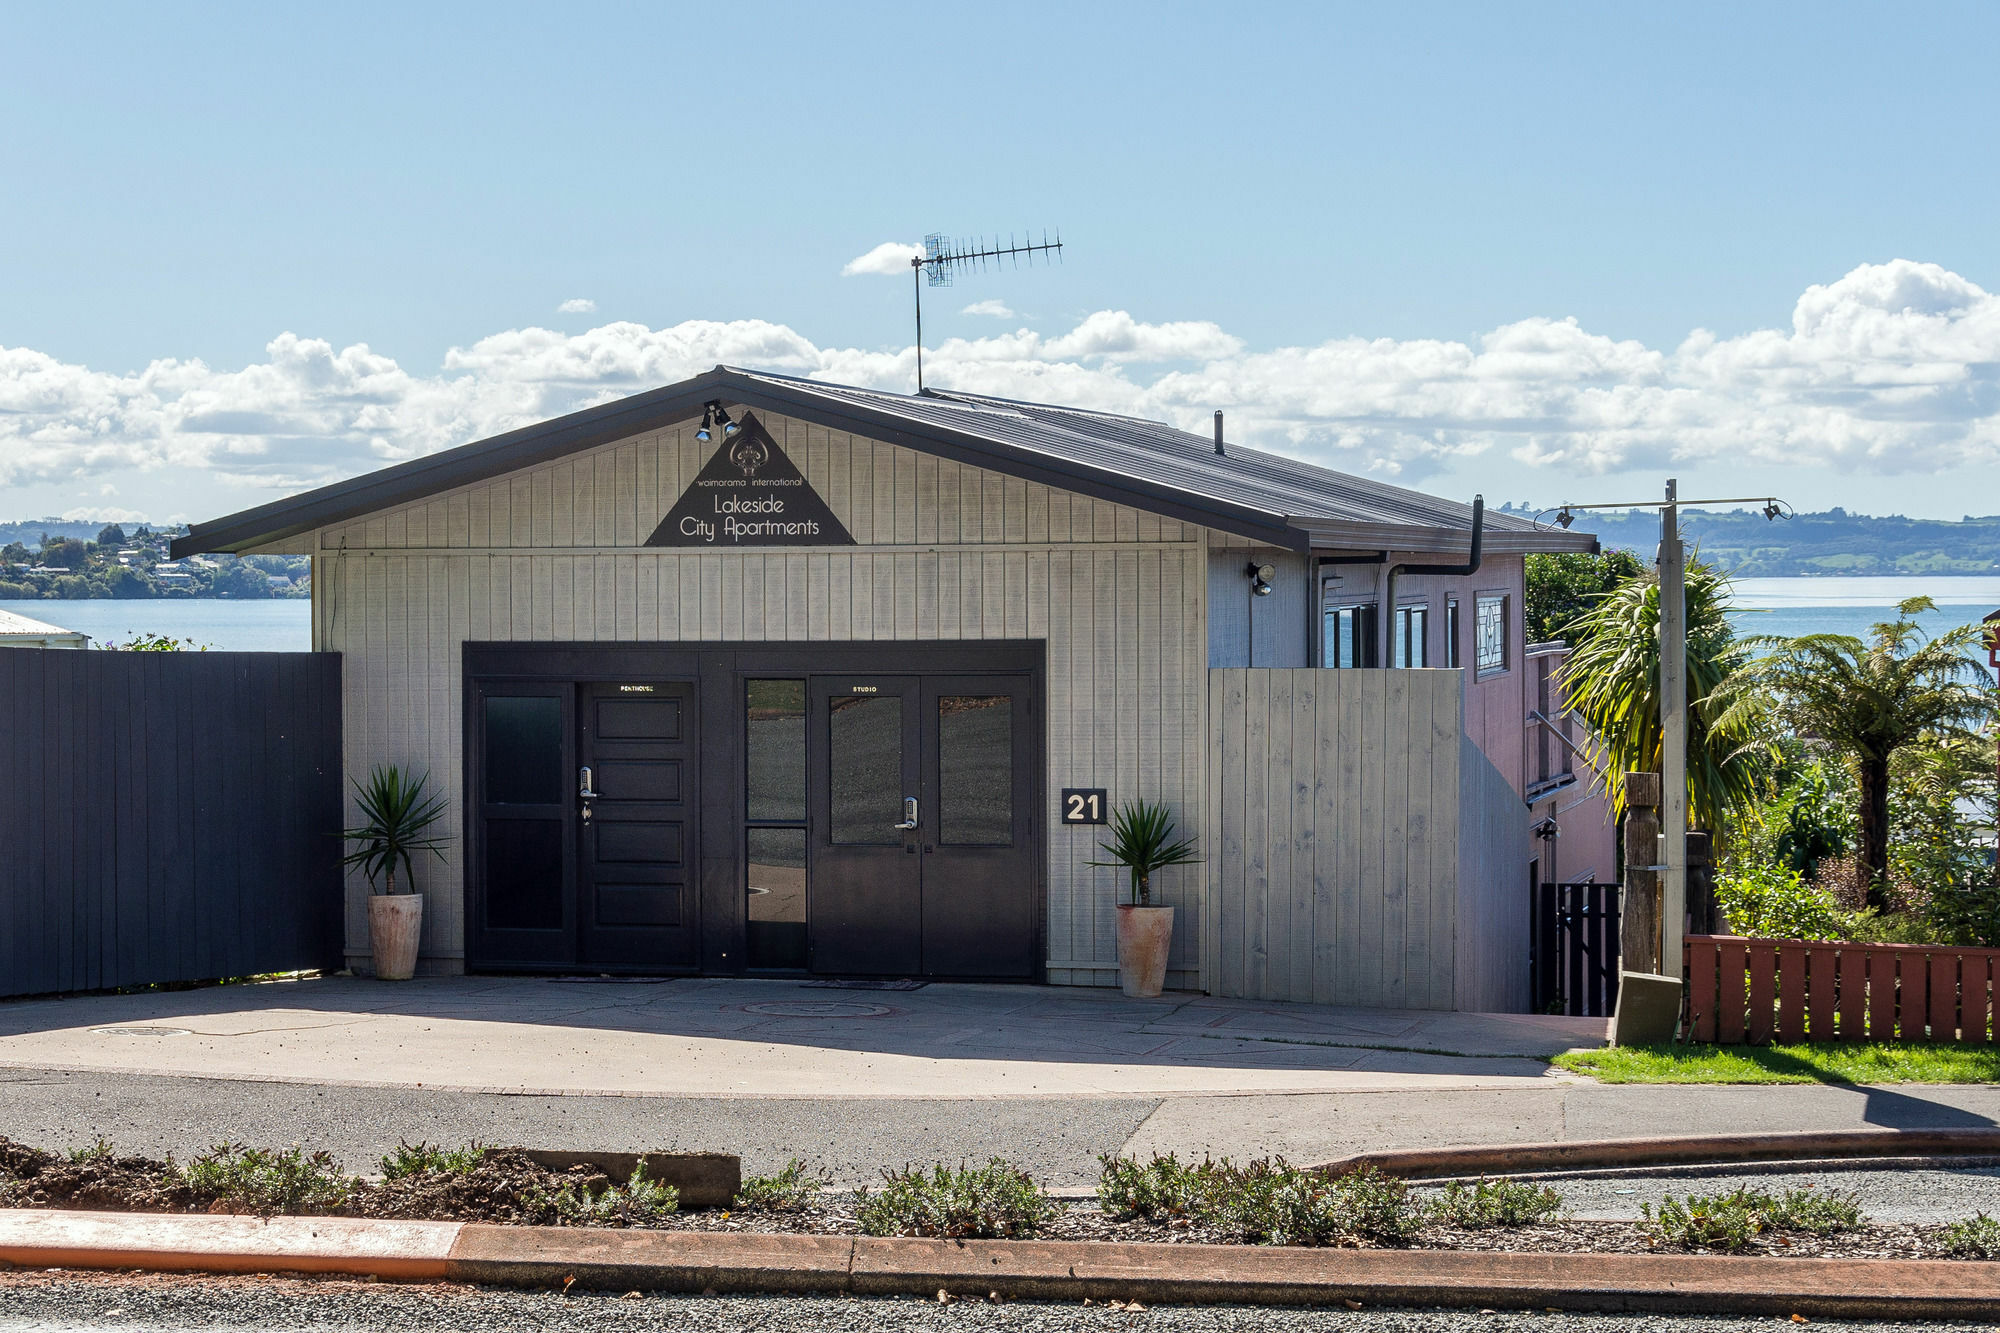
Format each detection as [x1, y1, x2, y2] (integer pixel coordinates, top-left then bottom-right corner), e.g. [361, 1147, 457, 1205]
[0, 1069, 1160, 1189]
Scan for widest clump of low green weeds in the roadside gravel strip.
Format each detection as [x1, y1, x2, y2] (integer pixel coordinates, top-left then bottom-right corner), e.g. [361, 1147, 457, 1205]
[1098, 1157, 1424, 1245]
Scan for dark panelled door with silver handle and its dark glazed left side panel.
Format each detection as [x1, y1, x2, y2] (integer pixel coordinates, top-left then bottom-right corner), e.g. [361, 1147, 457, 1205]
[470, 681, 698, 971]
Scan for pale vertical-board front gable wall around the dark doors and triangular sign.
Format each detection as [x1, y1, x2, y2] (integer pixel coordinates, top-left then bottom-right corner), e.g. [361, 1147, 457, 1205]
[316, 414, 1208, 987]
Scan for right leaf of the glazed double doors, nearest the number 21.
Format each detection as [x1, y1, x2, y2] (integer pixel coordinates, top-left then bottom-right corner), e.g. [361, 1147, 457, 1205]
[920, 677, 1036, 977]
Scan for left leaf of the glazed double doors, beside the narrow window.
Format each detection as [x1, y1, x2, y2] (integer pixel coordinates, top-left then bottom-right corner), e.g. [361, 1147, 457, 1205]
[806, 677, 924, 977]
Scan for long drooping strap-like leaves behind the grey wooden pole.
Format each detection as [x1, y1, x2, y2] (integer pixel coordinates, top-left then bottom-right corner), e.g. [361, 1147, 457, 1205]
[1562, 560, 1768, 829]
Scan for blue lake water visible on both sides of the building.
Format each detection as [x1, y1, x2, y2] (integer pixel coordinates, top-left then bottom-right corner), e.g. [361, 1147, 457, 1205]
[0, 574, 2000, 652]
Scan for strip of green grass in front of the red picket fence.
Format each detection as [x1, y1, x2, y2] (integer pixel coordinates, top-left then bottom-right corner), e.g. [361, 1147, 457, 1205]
[1550, 1041, 2000, 1083]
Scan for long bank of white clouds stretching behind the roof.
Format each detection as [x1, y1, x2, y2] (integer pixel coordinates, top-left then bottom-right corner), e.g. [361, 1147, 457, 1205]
[0, 260, 2000, 500]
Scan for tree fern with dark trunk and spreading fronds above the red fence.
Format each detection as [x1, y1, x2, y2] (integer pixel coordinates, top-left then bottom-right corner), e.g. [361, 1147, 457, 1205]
[1726, 596, 1994, 909]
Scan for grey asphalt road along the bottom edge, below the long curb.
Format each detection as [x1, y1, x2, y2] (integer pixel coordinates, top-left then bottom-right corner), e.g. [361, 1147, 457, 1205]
[0, 1273, 1986, 1333]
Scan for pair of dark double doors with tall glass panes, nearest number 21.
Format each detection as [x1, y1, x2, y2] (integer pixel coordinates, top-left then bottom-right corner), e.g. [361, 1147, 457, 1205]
[806, 675, 1038, 977]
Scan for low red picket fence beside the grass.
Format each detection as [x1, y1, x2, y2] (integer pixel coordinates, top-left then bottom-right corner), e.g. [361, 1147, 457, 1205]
[1682, 935, 2000, 1043]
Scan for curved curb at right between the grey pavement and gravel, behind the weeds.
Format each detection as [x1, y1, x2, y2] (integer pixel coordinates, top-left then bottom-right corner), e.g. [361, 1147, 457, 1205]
[1316, 1129, 2000, 1181]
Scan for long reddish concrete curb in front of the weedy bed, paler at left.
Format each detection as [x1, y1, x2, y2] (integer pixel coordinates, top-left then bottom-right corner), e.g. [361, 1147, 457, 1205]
[11, 1209, 2000, 1321]
